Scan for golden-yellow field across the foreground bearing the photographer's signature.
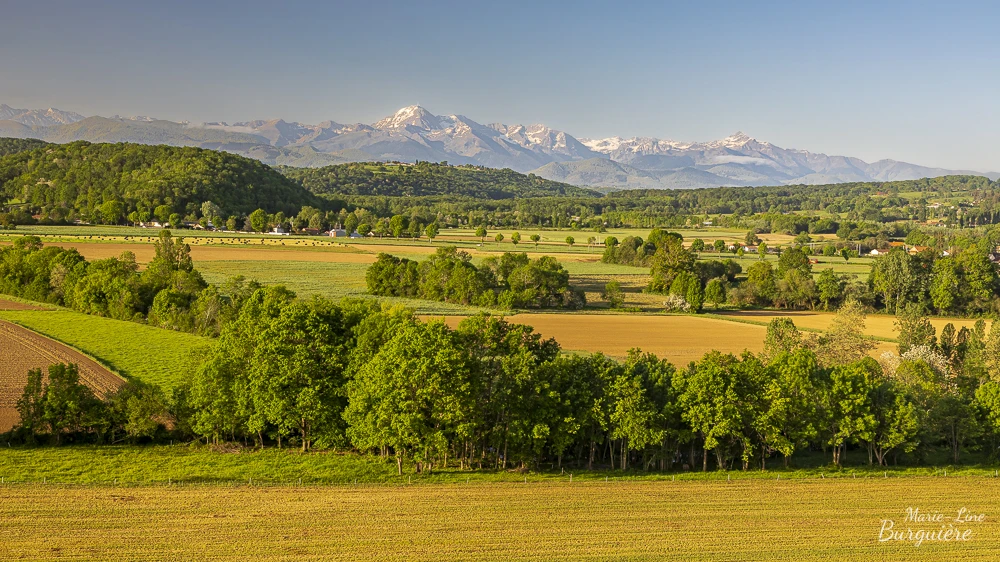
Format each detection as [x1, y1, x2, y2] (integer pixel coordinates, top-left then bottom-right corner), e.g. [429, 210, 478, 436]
[0, 477, 1000, 561]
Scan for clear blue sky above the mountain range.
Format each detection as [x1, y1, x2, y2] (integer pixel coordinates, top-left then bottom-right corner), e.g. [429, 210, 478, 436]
[0, 0, 1000, 171]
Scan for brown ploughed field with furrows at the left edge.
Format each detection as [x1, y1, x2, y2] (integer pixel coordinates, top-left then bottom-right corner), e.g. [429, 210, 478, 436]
[0, 320, 125, 432]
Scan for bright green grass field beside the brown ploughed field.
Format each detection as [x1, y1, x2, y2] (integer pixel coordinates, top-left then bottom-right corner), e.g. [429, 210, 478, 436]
[0, 309, 211, 389]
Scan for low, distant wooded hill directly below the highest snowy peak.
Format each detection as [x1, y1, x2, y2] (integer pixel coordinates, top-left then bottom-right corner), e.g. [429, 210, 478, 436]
[279, 162, 601, 200]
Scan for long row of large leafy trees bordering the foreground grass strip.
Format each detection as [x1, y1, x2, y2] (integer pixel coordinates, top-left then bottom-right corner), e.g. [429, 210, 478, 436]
[16, 296, 1000, 471]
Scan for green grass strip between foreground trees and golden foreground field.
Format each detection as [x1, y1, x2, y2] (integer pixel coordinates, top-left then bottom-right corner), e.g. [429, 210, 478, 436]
[0, 443, 997, 486]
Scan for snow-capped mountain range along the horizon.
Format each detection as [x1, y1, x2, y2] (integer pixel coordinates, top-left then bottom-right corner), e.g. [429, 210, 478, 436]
[0, 105, 1000, 189]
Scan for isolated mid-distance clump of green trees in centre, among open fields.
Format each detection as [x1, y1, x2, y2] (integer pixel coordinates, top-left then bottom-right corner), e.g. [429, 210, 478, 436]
[365, 247, 586, 309]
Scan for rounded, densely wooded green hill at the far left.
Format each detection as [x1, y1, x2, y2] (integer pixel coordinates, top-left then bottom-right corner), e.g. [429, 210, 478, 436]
[0, 141, 320, 220]
